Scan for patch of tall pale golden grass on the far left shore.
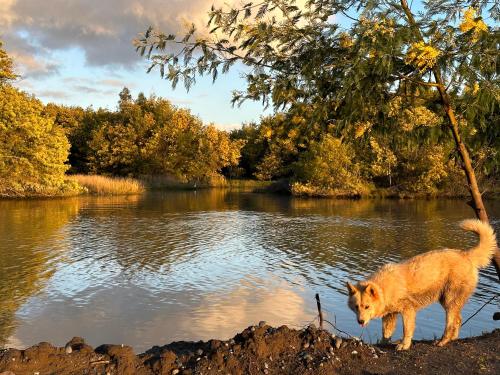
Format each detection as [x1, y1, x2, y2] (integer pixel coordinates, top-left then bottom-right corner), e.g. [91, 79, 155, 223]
[70, 174, 145, 195]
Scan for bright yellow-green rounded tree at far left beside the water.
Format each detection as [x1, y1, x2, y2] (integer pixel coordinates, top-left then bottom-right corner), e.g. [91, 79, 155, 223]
[0, 85, 76, 196]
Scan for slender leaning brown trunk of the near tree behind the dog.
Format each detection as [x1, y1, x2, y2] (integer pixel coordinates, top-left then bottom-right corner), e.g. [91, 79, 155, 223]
[401, 0, 500, 279]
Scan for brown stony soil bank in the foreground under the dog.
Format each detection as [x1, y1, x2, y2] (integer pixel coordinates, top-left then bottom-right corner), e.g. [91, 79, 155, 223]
[0, 322, 500, 375]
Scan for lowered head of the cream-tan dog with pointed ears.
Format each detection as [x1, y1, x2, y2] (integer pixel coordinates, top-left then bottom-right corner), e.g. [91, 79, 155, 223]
[347, 282, 381, 327]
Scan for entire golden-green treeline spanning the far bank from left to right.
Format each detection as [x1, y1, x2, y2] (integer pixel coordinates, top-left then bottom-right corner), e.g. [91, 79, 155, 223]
[0, 36, 500, 197]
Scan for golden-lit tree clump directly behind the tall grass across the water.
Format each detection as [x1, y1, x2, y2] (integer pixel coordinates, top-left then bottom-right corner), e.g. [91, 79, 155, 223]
[44, 88, 243, 182]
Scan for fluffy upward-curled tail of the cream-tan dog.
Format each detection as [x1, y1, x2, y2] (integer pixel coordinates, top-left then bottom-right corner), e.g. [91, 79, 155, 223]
[460, 219, 497, 268]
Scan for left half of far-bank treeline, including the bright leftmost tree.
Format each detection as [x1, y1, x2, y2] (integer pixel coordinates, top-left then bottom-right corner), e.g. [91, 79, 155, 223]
[0, 43, 244, 197]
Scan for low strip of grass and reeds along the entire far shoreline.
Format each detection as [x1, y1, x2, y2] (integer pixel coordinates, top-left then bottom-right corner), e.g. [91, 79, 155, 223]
[0, 174, 500, 200]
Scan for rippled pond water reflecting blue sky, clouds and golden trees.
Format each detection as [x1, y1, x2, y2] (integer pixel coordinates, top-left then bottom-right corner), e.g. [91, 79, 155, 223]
[0, 190, 500, 352]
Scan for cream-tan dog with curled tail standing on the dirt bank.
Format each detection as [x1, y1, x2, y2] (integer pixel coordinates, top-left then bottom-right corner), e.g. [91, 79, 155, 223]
[347, 220, 497, 350]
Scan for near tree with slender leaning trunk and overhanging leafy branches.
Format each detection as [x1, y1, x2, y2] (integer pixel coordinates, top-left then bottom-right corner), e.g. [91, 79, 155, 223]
[136, 0, 500, 277]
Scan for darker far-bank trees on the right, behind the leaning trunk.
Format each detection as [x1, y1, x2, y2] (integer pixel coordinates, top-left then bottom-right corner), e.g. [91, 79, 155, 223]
[231, 89, 500, 196]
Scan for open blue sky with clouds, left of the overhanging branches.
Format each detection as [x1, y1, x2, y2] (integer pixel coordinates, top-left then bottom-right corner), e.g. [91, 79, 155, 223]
[0, 0, 270, 129]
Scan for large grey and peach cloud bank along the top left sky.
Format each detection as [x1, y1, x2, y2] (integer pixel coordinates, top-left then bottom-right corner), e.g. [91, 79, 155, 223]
[0, 0, 239, 67]
